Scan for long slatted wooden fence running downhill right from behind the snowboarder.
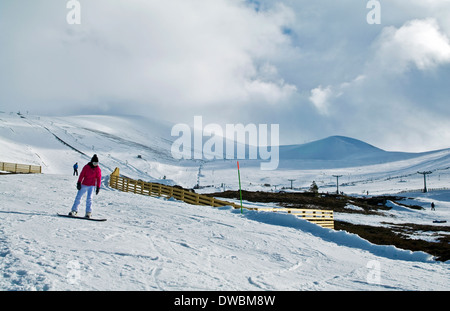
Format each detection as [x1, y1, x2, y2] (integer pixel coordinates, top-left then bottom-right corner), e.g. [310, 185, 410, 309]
[109, 168, 334, 229]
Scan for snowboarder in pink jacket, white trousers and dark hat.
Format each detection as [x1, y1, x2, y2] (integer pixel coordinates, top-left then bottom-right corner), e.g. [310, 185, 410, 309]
[69, 154, 102, 218]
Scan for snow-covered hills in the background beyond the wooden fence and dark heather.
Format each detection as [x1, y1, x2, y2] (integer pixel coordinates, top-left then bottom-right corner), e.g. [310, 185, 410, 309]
[0, 113, 450, 193]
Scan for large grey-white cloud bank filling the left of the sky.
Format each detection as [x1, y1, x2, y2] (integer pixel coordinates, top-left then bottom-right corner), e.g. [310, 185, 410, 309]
[0, 0, 295, 115]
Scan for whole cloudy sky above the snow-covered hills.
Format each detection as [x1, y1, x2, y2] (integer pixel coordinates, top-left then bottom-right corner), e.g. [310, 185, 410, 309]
[0, 0, 450, 151]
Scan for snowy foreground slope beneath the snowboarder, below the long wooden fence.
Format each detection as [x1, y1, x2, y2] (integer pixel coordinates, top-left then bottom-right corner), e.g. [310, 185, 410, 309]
[0, 175, 450, 291]
